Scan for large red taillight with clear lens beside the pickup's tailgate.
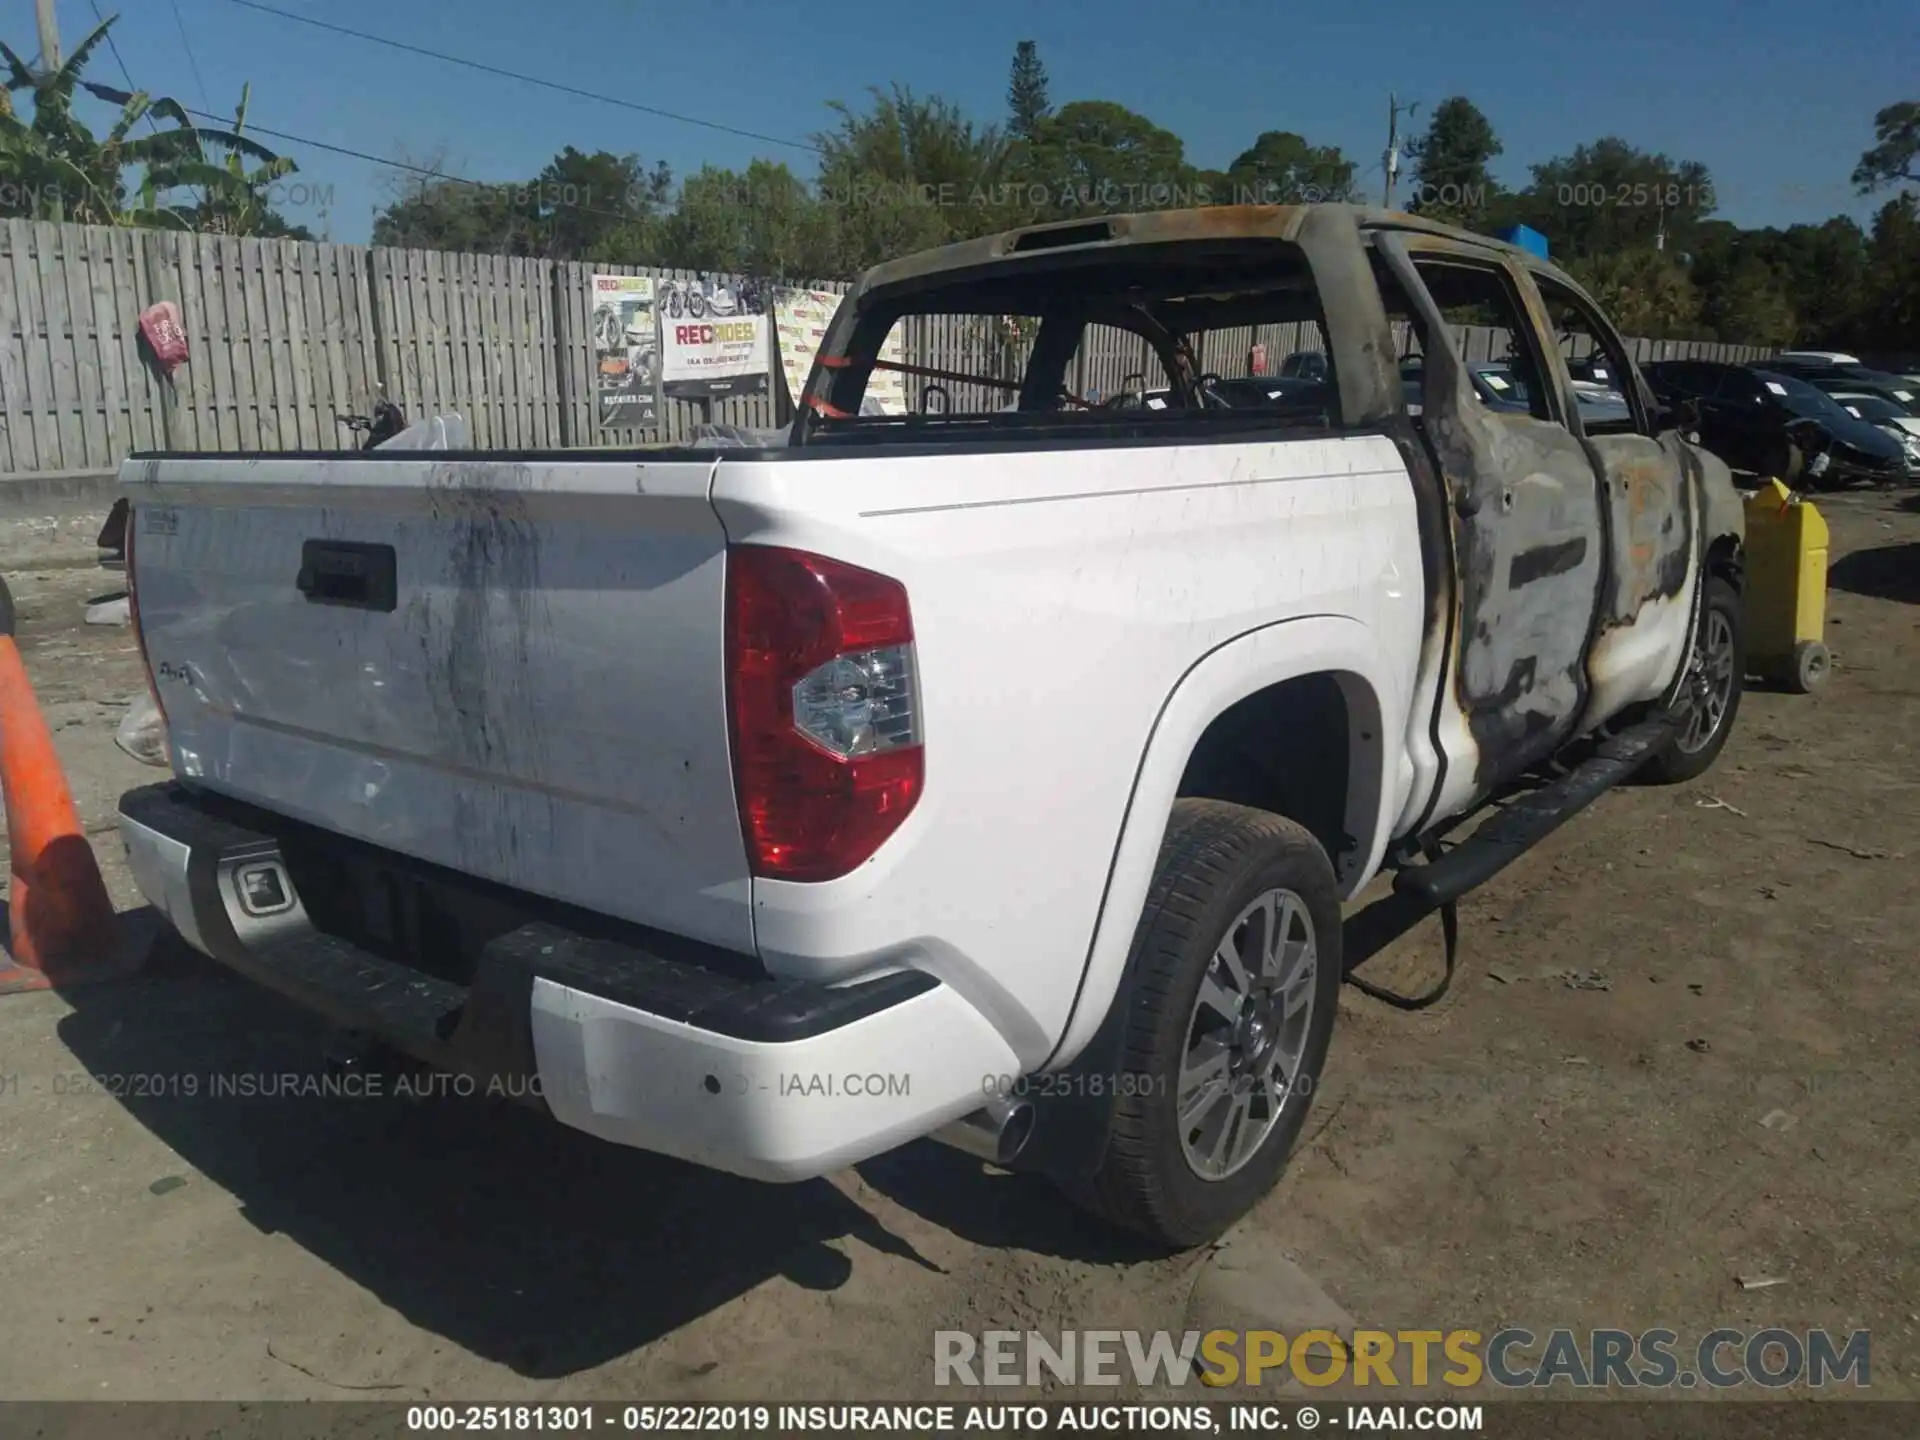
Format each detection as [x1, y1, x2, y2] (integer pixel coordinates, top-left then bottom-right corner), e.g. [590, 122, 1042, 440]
[726, 545, 925, 881]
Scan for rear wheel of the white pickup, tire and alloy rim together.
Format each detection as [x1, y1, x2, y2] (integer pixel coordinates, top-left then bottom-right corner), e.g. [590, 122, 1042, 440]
[1071, 801, 1342, 1248]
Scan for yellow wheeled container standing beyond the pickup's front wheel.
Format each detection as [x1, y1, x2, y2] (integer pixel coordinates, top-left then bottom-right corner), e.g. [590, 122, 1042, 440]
[1747, 480, 1830, 693]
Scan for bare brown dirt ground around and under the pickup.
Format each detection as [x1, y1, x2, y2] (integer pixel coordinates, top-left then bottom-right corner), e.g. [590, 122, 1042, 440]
[0, 495, 1920, 1402]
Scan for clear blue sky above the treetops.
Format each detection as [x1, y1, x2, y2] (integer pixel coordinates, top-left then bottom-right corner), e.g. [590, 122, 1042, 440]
[30, 0, 1920, 242]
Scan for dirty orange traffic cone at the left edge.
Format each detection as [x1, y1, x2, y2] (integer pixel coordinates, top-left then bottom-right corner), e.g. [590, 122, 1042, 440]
[0, 582, 136, 995]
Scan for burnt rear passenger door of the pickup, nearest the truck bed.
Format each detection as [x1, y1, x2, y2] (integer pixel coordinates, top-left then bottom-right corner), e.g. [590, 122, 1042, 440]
[1375, 232, 1607, 826]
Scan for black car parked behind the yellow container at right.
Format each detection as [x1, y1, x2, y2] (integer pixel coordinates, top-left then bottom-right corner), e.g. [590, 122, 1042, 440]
[1644, 361, 1907, 490]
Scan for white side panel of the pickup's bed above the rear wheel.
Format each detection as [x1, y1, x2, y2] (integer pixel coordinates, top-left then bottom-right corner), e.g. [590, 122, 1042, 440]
[714, 436, 1425, 1066]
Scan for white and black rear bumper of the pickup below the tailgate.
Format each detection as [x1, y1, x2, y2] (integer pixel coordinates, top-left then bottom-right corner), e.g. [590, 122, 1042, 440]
[121, 783, 1020, 1181]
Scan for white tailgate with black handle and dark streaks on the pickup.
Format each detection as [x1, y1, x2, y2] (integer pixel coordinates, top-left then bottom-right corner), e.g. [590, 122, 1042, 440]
[123, 455, 753, 950]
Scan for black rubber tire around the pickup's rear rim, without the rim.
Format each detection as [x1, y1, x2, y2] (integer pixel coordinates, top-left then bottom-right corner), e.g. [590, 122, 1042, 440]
[1069, 801, 1344, 1248]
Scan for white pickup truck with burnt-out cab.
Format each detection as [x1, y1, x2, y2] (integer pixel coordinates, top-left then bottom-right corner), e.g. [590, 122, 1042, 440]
[121, 205, 1741, 1246]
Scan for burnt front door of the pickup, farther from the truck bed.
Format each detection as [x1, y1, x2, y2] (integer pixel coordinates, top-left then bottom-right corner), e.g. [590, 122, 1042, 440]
[1521, 271, 1697, 732]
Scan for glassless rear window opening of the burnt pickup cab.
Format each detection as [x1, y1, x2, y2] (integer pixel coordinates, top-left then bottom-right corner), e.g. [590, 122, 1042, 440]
[801, 232, 1340, 444]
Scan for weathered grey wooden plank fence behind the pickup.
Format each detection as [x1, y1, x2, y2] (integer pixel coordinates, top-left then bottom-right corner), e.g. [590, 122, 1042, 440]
[0, 219, 1768, 478]
